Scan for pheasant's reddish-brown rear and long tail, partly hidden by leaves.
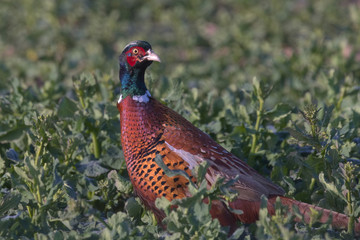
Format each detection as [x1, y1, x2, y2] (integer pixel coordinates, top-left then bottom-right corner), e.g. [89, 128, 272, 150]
[226, 196, 360, 235]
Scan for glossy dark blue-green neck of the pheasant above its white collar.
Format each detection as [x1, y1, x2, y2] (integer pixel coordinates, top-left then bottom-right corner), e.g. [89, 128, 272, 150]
[119, 64, 147, 98]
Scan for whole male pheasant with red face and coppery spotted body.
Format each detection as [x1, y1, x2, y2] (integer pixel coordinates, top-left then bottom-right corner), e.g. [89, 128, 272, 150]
[117, 41, 360, 233]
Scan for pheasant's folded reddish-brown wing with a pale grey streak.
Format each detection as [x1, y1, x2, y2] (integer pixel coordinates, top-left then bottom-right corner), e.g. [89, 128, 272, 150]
[158, 101, 284, 201]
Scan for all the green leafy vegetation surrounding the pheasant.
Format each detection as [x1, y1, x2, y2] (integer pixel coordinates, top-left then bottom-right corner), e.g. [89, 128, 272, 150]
[0, 0, 360, 239]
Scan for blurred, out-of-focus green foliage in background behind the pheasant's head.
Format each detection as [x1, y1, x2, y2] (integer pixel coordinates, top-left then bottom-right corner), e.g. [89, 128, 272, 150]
[0, 0, 360, 105]
